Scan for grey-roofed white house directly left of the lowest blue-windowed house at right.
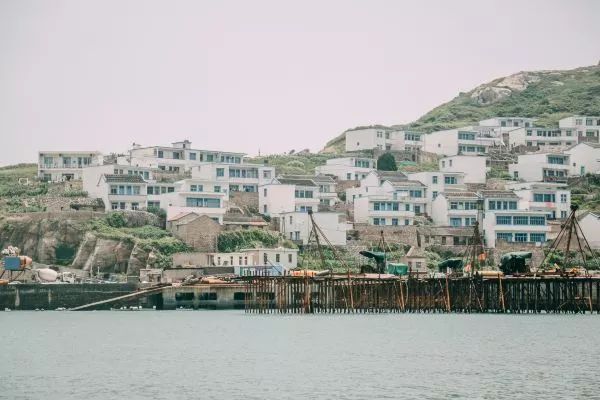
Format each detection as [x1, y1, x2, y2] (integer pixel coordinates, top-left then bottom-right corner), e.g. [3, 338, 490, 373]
[431, 192, 480, 227]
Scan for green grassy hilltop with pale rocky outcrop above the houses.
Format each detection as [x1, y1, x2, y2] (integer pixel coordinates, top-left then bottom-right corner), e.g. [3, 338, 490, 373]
[323, 65, 600, 153]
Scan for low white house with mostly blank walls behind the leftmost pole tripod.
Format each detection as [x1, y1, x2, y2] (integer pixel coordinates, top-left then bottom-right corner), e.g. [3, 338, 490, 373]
[279, 212, 348, 246]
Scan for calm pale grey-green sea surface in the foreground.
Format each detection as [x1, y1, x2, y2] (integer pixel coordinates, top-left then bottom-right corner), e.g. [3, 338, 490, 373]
[0, 311, 600, 400]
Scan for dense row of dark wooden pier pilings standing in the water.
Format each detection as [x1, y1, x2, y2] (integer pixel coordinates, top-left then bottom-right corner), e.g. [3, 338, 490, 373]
[245, 275, 600, 314]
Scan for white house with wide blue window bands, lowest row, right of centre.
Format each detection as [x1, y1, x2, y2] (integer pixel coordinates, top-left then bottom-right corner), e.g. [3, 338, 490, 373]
[482, 210, 550, 247]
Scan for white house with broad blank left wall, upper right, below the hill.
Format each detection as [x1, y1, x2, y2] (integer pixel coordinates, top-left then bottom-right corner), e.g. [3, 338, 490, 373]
[508, 153, 571, 182]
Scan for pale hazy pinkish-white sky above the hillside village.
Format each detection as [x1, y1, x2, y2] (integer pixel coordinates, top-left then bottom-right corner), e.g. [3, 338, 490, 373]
[0, 0, 600, 165]
